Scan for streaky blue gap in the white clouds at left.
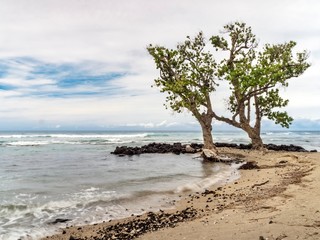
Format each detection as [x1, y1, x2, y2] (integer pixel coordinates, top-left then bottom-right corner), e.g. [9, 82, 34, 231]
[0, 57, 127, 98]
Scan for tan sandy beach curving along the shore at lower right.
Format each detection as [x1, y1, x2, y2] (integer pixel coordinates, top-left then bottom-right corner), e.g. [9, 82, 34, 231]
[45, 148, 320, 240]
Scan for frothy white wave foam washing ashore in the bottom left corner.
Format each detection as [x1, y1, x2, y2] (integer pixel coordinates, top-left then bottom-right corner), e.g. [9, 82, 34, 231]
[0, 187, 125, 240]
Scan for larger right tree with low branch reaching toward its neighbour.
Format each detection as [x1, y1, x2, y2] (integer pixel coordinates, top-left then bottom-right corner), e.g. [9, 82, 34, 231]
[210, 22, 310, 149]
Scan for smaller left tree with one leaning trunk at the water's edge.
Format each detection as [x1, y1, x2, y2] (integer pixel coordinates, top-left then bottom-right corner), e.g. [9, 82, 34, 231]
[147, 32, 217, 153]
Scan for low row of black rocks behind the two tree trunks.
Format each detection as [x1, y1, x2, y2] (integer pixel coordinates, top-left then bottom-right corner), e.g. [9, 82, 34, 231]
[112, 142, 316, 156]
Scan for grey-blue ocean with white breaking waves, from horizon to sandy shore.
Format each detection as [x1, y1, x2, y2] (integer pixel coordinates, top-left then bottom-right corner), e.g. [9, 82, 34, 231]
[0, 132, 320, 240]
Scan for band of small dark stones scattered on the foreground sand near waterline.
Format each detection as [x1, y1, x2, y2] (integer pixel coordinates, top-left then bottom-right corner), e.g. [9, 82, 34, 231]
[70, 207, 197, 240]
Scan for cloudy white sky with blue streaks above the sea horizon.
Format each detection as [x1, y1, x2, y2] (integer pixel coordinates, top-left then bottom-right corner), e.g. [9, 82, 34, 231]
[0, 0, 320, 130]
